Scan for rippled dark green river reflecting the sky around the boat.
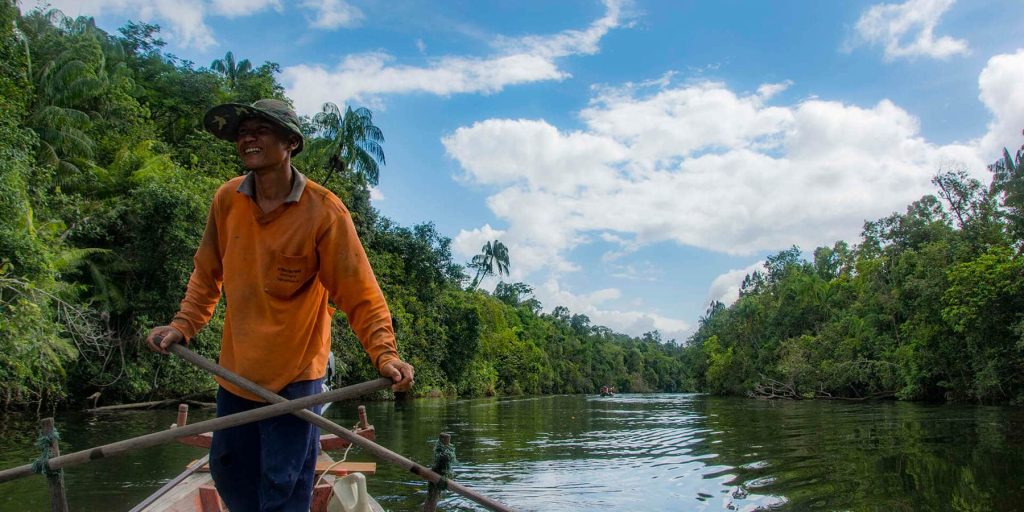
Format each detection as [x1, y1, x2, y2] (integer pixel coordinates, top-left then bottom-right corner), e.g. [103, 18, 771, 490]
[0, 394, 1024, 512]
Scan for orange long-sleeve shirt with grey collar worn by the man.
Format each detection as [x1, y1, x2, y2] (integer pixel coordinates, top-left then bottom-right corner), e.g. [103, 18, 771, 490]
[171, 168, 398, 401]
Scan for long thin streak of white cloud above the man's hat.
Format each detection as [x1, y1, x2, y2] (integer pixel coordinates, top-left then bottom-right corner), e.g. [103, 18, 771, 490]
[282, 0, 622, 114]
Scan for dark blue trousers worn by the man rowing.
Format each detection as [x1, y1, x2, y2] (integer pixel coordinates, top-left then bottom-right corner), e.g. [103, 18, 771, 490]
[210, 379, 323, 512]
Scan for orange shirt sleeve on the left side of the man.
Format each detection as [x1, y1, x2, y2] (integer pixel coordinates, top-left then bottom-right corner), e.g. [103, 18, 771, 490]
[171, 200, 224, 341]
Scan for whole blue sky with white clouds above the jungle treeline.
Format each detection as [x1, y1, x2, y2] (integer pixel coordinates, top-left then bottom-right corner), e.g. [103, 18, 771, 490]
[39, 0, 1024, 340]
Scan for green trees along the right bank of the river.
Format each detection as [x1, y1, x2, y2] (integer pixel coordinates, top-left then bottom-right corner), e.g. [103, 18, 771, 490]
[688, 141, 1024, 403]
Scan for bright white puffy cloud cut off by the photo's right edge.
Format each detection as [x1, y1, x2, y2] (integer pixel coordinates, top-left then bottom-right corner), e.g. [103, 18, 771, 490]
[978, 49, 1024, 161]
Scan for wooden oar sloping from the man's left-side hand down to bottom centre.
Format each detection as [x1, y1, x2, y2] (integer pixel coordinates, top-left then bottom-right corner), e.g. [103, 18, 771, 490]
[169, 344, 513, 512]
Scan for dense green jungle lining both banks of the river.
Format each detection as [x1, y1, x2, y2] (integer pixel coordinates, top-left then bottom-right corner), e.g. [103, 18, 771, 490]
[0, 0, 1024, 409]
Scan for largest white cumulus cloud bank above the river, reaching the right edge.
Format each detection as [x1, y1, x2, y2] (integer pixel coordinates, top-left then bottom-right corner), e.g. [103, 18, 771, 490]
[442, 50, 1024, 334]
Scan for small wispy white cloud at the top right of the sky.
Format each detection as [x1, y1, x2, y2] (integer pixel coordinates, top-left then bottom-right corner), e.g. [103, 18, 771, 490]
[856, 0, 970, 60]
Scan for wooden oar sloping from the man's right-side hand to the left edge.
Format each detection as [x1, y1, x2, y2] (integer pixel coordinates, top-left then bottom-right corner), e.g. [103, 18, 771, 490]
[0, 376, 391, 482]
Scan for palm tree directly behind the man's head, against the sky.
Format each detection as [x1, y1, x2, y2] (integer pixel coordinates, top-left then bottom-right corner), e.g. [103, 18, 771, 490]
[313, 101, 386, 185]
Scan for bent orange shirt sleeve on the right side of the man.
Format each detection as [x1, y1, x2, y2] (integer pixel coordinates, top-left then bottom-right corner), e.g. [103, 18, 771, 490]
[316, 209, 399, 370]
